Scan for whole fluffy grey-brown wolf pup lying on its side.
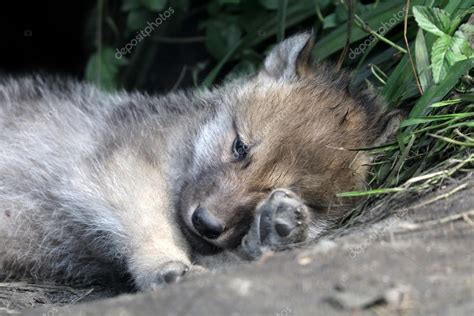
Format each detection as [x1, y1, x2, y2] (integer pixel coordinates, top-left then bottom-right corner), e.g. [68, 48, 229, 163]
[0, 34, 397, 289]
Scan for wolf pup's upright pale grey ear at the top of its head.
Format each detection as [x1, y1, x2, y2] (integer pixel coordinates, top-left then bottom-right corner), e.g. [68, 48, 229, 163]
[260, 32, 314, 80]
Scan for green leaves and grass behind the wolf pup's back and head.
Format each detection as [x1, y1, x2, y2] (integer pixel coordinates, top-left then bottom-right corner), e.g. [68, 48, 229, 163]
[85, 0, 474, 207]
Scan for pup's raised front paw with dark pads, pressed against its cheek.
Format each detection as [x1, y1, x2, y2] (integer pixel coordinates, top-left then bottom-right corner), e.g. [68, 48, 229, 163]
[242, 189, 310, 259]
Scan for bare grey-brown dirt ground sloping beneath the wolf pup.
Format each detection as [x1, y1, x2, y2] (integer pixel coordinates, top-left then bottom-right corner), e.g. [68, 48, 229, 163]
[0, 176, 474, 316]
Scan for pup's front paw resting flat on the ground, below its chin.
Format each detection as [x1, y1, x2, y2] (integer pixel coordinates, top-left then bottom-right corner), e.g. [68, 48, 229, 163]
[135, 261, 189, 291]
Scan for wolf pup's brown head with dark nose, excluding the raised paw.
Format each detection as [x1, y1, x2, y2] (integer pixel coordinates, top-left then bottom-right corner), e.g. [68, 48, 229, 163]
[179, 34, 398, 248]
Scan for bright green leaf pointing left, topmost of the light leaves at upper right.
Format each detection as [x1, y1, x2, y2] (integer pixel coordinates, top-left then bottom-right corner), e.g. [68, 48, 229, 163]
[413, 6, 453, 36]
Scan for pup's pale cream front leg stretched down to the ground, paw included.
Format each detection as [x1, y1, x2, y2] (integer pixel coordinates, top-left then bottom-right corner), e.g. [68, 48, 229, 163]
[96, 149, 191, 290]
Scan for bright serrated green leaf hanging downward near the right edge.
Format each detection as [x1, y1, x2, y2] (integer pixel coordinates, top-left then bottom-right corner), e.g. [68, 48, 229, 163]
[431, 35, 469, 83]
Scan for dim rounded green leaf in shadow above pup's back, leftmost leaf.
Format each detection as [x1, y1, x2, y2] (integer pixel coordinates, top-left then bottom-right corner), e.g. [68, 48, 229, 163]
[85, 47, 126, 90]
